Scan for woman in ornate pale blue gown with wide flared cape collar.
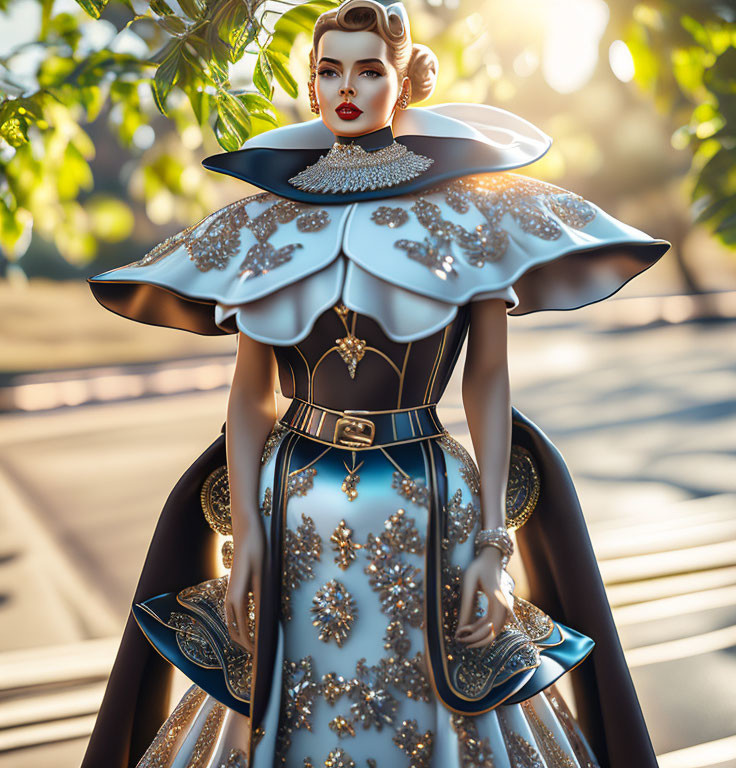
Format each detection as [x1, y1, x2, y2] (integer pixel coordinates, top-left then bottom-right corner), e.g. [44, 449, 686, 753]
[84, 0, 668, 768]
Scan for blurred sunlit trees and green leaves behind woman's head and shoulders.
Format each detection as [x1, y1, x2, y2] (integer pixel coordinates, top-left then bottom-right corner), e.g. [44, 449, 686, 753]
[0, 0, 736, 291]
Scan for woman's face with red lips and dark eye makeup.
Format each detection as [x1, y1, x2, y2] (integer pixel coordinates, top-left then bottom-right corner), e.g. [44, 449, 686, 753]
[314, 29, 402, 136]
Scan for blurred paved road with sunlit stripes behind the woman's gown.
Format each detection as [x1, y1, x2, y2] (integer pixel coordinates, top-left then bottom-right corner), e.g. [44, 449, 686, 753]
[0, 316, 736, 768]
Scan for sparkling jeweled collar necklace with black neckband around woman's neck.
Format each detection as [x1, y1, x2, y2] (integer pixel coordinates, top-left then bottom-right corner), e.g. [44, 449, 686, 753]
[289, 125, 434, 194]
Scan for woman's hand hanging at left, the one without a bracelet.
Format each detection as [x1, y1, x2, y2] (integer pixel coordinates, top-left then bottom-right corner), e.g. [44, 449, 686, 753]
[225, 519, 265, 653]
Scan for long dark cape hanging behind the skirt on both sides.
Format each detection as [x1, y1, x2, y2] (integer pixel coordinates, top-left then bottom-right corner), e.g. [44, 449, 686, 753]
[81, 408, 657, 768]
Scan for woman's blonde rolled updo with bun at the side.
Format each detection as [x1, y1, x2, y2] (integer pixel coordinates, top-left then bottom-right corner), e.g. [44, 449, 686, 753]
[309, 0, 438, 102]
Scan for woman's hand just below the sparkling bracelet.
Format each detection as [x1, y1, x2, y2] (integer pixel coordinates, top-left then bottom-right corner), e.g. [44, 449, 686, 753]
[455, 547, 509, 648]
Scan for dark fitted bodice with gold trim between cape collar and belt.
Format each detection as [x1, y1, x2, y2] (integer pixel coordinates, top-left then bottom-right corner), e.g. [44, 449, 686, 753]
[274, 304, 470, 411]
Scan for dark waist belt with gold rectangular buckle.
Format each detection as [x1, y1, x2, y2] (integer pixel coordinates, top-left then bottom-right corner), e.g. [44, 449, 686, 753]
[280, 399, 445, 450]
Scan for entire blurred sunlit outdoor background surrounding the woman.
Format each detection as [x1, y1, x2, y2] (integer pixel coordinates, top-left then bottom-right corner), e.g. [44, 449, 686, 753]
[0, 0, 736, 768]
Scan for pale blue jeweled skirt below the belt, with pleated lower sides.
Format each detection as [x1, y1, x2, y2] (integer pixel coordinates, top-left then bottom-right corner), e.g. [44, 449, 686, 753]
[139, 432, 597, 768]
